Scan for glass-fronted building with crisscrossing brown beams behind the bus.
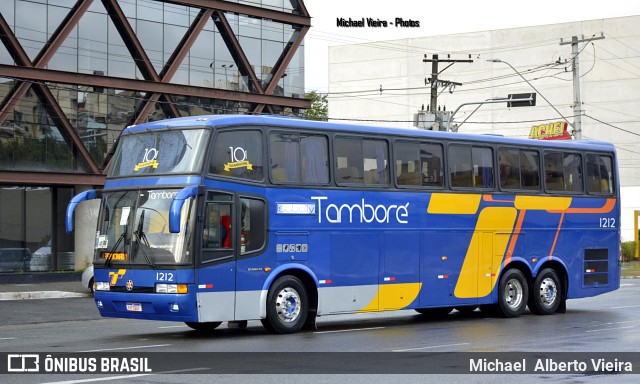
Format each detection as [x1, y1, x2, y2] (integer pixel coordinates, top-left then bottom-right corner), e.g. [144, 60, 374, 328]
[0, 0, 310, 273]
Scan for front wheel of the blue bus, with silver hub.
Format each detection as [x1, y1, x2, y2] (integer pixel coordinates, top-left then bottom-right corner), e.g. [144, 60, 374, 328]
[261, 276, 309, 333]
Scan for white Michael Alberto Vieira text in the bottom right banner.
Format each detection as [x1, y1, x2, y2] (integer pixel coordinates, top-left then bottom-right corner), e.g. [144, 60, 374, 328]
[469, 358, 633, 373]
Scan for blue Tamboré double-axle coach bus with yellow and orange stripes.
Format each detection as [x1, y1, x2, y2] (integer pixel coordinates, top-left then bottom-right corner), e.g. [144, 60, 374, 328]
[66, 115, 620, 333]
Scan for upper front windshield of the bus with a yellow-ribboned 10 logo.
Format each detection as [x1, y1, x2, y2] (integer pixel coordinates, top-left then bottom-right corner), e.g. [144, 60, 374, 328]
[109, 128, 209, 177]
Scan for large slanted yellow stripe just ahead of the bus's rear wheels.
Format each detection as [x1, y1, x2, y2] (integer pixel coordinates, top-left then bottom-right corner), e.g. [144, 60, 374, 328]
[454, 207, 518, 299]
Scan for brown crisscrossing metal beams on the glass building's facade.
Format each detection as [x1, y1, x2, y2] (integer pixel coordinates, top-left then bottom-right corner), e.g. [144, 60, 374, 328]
[0, 0, 311, 185]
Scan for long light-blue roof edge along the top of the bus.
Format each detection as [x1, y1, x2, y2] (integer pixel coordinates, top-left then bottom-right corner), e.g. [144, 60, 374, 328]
[123, 115, 615, 152]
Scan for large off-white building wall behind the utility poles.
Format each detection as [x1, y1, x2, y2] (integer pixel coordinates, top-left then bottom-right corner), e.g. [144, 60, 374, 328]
[328, 16, 640, 187]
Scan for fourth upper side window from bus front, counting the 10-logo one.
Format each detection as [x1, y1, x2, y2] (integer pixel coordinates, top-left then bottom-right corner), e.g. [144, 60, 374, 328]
[394, 142, 444, 187]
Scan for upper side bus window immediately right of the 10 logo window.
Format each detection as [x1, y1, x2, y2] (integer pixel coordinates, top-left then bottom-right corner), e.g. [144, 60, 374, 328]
[269, 133, 329, 184]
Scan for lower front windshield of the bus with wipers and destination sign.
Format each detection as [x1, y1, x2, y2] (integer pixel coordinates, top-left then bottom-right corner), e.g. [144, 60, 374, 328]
[95, 189, 194, 268]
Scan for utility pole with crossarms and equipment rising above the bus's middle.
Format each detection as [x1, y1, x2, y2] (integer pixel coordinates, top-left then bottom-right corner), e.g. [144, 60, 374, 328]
[415, 54, 473, 130]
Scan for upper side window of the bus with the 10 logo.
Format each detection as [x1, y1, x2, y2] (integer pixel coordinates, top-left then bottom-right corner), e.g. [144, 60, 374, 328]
[209, 130, 263, 181]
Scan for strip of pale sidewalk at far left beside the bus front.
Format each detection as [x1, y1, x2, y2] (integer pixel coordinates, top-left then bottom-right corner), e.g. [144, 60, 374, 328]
[0, 272, 91, 301]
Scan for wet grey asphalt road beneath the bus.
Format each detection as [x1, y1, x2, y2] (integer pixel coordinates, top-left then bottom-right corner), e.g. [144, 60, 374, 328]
[0, 279, 640, 383]
